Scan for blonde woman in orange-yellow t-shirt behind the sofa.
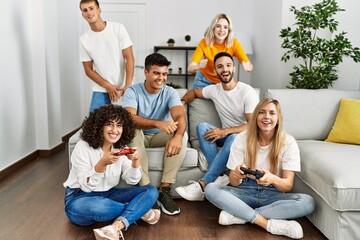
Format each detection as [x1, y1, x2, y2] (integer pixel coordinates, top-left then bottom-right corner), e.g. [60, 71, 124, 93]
[188, 13, 253, 89]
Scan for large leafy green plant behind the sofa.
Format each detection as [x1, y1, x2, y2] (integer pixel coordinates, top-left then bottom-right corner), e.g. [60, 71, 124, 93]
[280, 0, 360, 89]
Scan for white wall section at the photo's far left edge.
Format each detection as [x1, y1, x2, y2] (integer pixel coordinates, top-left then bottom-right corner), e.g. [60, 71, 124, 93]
[0, 0, 37, 169]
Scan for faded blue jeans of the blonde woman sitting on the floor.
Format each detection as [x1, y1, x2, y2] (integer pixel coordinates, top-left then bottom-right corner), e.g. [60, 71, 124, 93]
[205, 178, 315, 223]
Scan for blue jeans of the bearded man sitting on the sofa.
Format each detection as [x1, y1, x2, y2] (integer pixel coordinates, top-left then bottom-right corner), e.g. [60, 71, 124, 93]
[196, 123, 237, 184]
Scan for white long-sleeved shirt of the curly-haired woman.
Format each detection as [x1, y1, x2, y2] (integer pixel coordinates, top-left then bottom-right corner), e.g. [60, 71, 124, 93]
[63, 139, 142, 192]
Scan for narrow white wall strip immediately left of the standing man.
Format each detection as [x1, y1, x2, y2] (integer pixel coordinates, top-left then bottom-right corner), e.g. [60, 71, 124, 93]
[57, 0, 84, 135]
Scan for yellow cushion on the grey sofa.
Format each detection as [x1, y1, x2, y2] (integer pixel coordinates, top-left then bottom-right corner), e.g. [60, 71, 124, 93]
[326, 98, 360, 144]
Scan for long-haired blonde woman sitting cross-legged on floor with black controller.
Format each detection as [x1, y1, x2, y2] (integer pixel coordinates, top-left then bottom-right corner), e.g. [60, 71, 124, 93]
[205, 99, 315, 239]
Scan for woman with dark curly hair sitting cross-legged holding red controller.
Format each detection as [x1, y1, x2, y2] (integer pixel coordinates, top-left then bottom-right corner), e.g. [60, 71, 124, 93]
[64, 105, 160, 239]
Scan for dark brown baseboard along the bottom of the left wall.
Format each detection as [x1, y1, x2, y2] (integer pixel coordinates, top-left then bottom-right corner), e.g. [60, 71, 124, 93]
[0, 128, 80, 181]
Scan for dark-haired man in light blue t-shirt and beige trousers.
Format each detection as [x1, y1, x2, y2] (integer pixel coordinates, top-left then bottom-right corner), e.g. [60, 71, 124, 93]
[122, 53, 188, 215]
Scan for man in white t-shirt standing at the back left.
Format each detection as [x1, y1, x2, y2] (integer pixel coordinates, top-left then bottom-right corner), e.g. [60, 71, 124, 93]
[79, 0, 134, 112]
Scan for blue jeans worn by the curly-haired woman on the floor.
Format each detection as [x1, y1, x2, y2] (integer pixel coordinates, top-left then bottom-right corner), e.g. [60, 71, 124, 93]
[65, 186, 159, 230]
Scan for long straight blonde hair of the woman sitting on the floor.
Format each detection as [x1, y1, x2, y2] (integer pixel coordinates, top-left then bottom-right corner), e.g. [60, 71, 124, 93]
[246, 98, 285, 174]
